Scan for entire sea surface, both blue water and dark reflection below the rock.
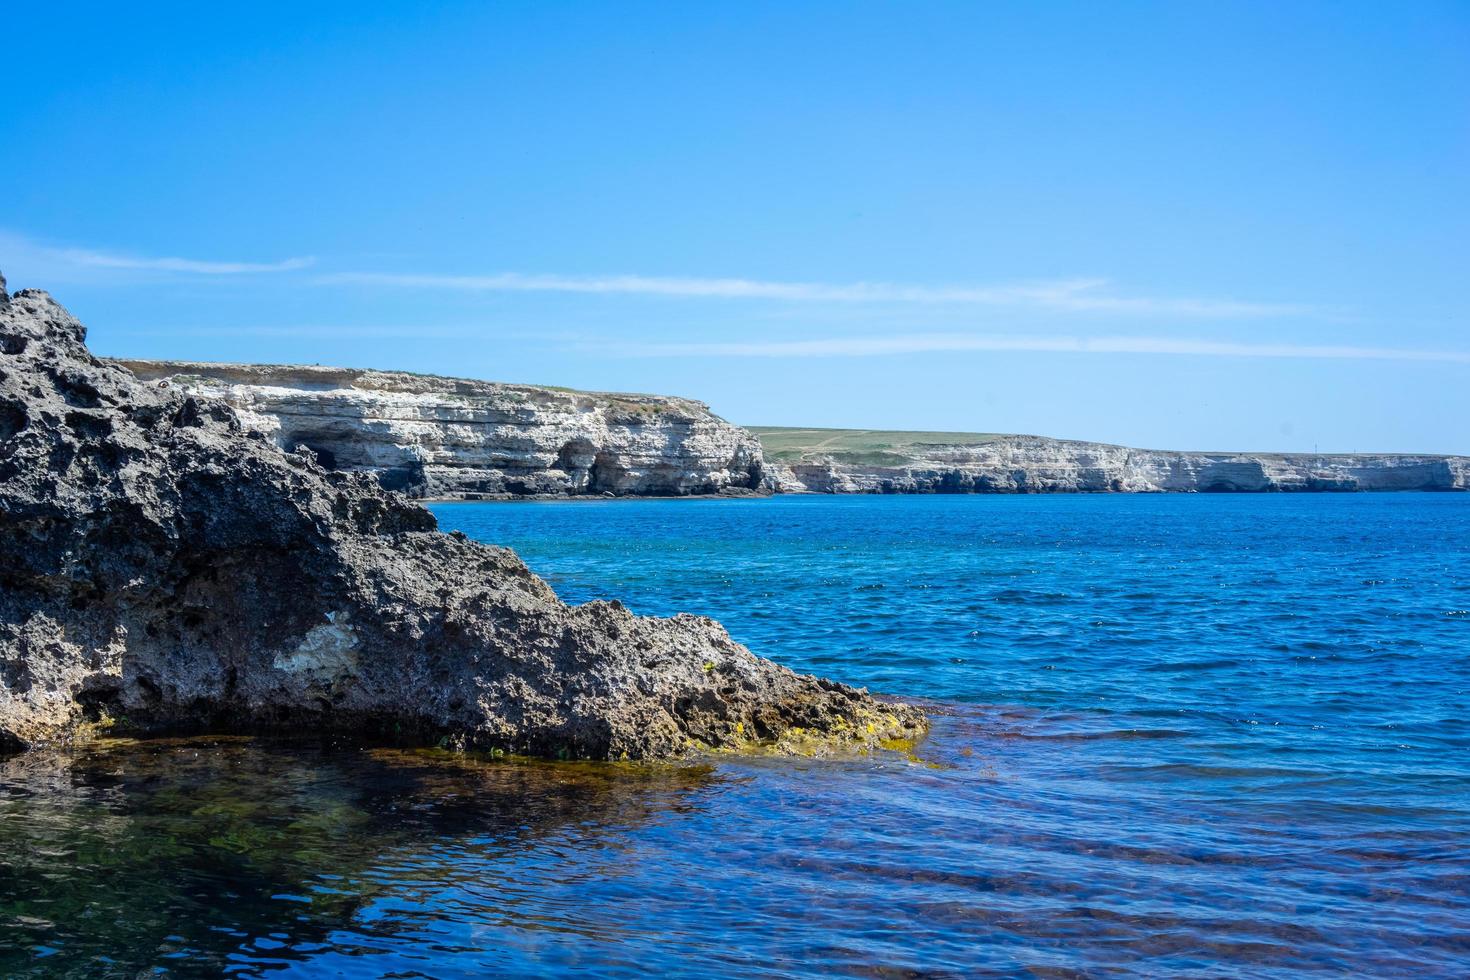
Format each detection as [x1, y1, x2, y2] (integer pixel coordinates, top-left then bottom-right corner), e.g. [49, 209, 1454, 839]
[0, 494, 1470, 977]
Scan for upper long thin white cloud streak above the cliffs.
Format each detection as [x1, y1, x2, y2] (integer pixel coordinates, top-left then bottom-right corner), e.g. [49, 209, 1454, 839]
[318, 272, 1319, 317]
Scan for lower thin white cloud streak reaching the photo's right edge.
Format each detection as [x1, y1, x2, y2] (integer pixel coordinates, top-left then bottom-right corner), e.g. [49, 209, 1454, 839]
[584, 334, 1470, 364]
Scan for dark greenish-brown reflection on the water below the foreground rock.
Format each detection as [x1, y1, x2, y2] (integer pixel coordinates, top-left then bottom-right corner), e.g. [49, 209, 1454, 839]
[0, 738, 713, 977]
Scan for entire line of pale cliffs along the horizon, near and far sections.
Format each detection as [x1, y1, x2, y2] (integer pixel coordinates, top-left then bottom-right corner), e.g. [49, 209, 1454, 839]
[97, 370, 1470, 500]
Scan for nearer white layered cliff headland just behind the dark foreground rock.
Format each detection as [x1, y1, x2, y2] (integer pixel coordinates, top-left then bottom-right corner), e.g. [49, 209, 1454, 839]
[118, 360, 769, 500]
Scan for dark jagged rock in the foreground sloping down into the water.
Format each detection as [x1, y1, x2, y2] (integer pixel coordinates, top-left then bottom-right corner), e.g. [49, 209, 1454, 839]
[0, 279, 923, 758]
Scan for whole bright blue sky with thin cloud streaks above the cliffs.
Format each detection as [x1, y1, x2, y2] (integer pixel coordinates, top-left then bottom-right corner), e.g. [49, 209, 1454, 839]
[0, 1, 1470, 453]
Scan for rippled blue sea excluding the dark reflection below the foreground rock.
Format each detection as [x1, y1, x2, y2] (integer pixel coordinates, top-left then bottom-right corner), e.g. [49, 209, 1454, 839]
[437, 494, 1470, 976]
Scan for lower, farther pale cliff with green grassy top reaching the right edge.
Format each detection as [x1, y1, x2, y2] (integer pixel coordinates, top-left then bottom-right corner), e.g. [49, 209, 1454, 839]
[754, 428, 1470, 494]
